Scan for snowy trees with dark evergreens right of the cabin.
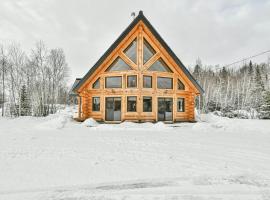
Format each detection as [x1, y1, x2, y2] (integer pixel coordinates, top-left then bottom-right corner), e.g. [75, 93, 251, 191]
[193, 59, 270, 119]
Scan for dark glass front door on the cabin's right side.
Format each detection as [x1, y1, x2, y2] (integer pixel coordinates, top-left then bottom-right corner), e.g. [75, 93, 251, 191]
[158, 98, 173, 121]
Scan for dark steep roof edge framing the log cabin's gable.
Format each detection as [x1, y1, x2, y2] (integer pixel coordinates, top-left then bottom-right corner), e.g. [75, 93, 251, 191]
[73, 11, 204, 93]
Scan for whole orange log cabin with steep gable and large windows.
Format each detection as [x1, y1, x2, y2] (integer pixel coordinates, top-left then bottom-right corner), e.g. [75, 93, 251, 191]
[72, 11, 203, 123]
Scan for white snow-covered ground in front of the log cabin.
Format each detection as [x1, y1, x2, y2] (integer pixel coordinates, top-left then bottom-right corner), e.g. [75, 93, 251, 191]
[0, 108, 270, 200]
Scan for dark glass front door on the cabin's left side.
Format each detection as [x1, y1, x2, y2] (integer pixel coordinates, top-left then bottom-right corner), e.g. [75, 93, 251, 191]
[105, 97, 121, 121]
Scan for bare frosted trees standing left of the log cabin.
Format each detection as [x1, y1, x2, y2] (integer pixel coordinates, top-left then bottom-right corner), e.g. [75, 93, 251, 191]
[0, 41, 68, 116]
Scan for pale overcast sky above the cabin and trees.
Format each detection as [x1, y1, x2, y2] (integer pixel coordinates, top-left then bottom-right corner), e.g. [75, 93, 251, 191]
[0, 0, 270, 83]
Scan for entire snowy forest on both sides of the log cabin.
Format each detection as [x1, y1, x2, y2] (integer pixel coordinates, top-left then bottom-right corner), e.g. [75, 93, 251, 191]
[0, 41, 270, 119]
